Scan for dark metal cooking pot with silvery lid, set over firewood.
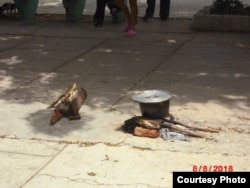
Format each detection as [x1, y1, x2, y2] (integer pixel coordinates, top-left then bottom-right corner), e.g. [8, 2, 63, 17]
[132, 90, 172, 119]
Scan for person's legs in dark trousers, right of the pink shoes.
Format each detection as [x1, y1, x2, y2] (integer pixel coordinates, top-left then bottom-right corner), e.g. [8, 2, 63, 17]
[142, 0, 170, 21]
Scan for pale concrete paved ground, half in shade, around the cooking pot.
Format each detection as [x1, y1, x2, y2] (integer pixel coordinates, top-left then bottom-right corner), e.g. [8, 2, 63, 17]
[0, 1, 250, 188]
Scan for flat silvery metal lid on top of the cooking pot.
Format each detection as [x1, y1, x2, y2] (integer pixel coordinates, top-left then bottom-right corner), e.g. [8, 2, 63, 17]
[132, 90, 172, 103]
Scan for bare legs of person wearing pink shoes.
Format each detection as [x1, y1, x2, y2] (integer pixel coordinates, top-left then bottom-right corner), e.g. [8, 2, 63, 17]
[115, 0, 138, 37]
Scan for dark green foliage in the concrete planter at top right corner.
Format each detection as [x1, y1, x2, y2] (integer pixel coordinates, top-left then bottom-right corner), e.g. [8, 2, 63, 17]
[210, 0, 250, 15]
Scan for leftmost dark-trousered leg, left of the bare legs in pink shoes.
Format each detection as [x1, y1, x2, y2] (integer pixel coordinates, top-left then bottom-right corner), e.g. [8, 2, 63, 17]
[94, 0, 107, 27]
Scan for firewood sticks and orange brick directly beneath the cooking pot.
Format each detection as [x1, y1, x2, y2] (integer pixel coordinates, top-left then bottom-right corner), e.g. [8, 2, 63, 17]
[123, 116, 220, 138]
